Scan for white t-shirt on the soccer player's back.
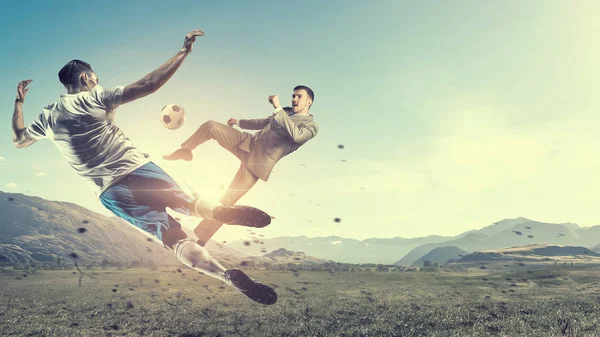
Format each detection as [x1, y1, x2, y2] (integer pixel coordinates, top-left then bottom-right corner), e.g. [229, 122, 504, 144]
[25, 85, 150, 196]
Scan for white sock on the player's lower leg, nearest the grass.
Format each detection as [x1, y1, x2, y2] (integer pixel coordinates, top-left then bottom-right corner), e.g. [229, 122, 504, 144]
[175, 238, 227, 281]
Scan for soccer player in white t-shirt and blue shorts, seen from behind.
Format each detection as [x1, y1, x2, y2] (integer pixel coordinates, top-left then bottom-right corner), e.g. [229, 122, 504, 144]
[12, 30, 277, 304]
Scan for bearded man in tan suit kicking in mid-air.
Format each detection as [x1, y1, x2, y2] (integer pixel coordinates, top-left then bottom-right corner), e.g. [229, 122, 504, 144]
[163, 85, 319, 246]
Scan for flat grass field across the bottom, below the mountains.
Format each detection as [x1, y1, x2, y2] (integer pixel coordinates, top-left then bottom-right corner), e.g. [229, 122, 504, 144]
[0, 265, 600, 337]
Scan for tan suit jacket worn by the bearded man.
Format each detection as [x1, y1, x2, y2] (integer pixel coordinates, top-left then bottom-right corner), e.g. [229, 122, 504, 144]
[238, 109, 319, 181]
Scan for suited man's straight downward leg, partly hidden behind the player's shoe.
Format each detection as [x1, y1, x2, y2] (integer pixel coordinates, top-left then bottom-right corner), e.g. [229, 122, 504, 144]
[194, 160, 258, 246]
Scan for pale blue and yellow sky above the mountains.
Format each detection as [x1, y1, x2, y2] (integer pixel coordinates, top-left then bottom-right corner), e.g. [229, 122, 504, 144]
[0, 0, 600, 240]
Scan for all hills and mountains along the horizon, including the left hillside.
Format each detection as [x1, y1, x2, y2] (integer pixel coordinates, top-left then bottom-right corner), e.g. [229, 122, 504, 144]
[0, 191, 600, 266]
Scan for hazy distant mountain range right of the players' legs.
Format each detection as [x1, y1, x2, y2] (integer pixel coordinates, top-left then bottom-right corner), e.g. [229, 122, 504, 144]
[228, 217, 600, 266]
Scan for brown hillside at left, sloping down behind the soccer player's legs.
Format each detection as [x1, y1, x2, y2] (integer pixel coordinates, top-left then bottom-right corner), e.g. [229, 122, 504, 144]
[0, 191, 325, 267]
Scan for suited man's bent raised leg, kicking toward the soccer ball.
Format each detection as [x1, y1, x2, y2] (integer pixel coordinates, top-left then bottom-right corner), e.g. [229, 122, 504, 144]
[163, 121, 250, 161]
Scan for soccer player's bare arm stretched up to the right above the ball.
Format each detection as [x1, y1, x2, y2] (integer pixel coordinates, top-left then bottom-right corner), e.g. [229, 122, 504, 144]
[122, 29, 204, 104]
